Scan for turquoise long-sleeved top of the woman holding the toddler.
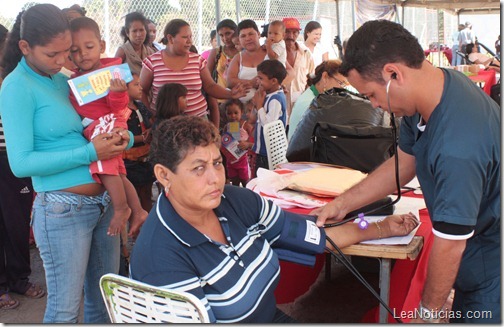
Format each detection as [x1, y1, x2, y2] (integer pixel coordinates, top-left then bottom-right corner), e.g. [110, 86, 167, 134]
[0, 58, 133, 192]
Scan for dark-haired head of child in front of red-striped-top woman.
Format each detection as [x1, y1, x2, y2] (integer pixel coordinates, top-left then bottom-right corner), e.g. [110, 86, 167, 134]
[152, 83, 187, 130]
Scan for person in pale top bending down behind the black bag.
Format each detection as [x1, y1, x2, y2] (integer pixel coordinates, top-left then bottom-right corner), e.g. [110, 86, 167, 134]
[287, 59, 349, 140]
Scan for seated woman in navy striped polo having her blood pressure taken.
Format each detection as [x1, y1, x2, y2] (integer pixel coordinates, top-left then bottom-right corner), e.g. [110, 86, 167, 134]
[130, 116, 417, 323]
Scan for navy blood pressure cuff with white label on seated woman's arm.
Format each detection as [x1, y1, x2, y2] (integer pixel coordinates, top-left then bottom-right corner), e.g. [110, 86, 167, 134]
[272, 213, 326, 267]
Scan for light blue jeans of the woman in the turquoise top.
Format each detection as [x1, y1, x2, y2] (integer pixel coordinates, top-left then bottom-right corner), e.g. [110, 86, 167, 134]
[32, 192, 119, 324]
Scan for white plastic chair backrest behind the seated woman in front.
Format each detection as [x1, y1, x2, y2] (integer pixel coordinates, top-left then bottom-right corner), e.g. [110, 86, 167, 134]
[100, 274, 210, 323]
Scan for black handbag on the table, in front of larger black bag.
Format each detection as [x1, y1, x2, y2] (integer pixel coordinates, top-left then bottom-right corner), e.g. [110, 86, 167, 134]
[310, 122, 394, 173]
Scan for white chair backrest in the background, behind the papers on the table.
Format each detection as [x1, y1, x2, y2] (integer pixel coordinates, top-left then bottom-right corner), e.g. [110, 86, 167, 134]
[263, 120, 287, 170]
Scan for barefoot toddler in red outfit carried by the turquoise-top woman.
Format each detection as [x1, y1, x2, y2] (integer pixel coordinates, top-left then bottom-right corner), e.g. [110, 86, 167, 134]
[70, 17, 147, 236]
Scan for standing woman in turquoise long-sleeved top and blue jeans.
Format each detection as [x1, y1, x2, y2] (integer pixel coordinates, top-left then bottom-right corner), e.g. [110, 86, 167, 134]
[0, 4, 142, 323]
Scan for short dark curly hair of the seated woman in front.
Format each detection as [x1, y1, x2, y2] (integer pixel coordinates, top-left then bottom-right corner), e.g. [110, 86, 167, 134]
[149, 116, 221, 173]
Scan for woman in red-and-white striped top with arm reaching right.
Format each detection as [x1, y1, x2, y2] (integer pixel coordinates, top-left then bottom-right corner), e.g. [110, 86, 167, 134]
[140, 19, 247, 116]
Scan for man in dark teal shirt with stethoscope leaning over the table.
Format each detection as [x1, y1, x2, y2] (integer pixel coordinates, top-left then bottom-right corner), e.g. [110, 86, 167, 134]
[313, 21, 501, 323]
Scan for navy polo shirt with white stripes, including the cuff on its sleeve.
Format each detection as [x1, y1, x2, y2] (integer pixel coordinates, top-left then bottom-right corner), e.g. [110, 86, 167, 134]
[130, 186, 325, 323]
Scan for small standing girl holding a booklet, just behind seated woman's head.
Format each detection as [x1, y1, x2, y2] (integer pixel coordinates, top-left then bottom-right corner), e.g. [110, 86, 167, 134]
[223, 99, 254, 186]
